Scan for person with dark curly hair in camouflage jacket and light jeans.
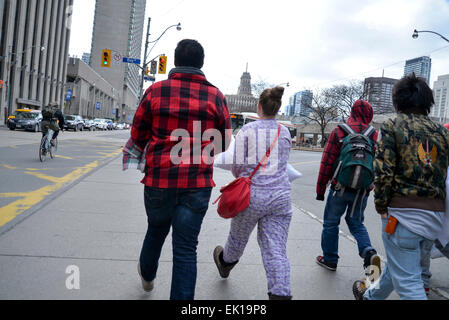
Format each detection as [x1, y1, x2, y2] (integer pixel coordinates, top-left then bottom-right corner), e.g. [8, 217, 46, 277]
[353, 74, 449, 300]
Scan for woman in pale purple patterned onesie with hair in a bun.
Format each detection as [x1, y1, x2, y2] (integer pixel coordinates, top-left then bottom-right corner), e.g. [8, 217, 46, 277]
[214, 87, 292, 300]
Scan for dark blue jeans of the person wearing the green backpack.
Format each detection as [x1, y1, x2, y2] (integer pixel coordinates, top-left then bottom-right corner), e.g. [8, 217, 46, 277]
[321, 189, 373, 263]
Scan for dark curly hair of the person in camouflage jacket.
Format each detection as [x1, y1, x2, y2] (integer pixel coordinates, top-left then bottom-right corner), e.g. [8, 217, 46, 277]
[393, 73, 435, 115]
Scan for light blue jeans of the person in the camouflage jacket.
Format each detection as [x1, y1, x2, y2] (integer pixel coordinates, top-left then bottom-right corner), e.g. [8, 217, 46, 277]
[363, 219, 433, 300]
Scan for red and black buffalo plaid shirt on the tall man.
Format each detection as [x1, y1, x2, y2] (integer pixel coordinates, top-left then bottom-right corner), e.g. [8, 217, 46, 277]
[131, 69, 231, 188]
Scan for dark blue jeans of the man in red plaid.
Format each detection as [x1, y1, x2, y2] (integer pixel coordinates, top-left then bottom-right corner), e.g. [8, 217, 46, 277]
[140, 186, 212, 300]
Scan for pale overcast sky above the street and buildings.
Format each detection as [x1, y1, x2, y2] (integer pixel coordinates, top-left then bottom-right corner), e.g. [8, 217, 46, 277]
[70, 0, 449, 106]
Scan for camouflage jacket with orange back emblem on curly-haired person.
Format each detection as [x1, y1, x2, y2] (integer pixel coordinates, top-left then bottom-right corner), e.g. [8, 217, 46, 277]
[374, 113, 449, 213]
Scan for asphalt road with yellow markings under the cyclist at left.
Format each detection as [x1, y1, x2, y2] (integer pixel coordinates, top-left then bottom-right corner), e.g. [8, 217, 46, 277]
[0, 127, 129, 233]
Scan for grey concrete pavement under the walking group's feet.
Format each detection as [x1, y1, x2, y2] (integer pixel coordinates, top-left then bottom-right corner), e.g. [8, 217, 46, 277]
[0, 157, 442, 300]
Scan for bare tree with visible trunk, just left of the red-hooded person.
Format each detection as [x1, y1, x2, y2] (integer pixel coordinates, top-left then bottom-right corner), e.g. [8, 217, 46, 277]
[302, 89, 340, 148]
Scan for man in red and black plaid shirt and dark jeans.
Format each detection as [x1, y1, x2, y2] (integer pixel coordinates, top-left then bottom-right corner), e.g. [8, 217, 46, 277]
[127, 39, 228, 300]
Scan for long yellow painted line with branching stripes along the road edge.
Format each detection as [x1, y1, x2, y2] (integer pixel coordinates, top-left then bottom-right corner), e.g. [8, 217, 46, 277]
[0, 149, 121, 227]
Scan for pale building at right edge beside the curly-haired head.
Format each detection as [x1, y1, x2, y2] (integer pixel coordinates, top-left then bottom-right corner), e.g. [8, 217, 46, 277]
[430, 74, 449, 124]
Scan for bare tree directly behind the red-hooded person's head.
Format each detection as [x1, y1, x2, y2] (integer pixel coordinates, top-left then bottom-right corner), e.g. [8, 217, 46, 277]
[324, 80, 366, 121]
